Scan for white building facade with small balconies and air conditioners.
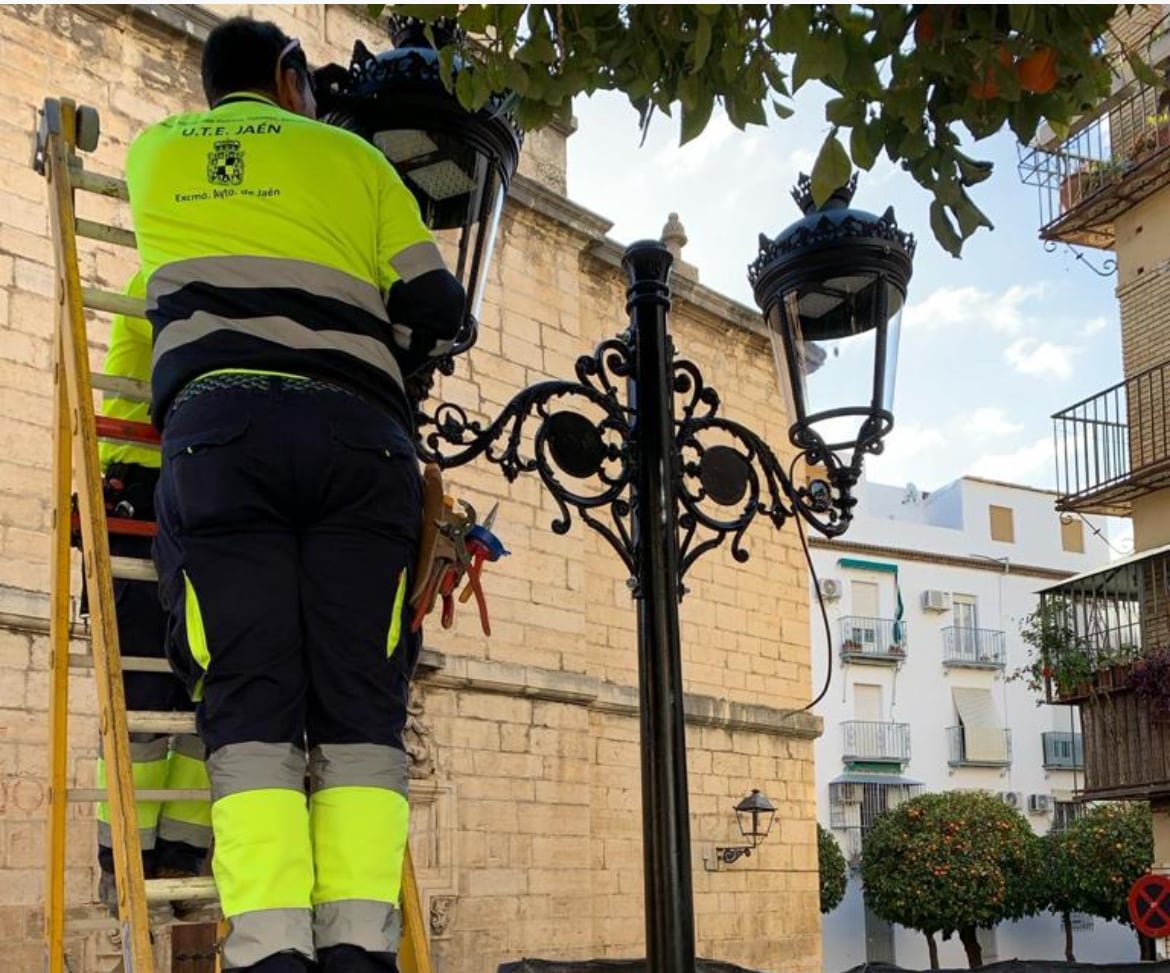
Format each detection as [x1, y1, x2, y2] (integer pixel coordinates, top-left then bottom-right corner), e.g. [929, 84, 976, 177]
[811, 477, 1137, 973]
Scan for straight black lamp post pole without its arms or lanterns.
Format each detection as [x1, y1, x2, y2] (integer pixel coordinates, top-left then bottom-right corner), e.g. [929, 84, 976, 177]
[622, 241, 695, 973]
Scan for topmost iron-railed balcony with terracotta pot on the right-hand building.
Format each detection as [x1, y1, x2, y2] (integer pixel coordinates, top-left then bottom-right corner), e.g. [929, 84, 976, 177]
[1019, 67, 1170, 249]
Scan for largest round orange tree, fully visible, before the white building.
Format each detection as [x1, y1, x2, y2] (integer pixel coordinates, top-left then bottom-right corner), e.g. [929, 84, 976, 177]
[861, 791, 1044, 969]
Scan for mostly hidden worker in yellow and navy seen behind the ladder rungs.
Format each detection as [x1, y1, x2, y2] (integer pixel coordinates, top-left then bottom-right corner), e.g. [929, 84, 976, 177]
[97, 272, 212, 918]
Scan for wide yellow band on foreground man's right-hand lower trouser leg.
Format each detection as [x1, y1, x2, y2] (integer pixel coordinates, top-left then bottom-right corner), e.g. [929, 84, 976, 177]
[311, 787, 411, 905]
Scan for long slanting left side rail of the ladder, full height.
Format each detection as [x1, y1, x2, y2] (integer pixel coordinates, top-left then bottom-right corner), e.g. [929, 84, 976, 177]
[44, 99, 154, 973]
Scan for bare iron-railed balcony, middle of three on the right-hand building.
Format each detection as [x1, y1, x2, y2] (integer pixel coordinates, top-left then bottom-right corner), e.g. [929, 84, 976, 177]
[1052, 357, 1170, 517]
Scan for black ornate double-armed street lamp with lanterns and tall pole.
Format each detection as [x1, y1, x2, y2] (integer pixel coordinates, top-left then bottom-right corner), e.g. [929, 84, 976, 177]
[326, 17, 914, 973]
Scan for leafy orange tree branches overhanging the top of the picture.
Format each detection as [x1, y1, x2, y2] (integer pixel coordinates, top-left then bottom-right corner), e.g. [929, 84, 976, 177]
[371, 4, 1161, 256]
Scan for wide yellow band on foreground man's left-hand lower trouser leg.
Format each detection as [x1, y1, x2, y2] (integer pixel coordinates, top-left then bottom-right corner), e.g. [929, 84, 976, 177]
[212, 788, 311, 921]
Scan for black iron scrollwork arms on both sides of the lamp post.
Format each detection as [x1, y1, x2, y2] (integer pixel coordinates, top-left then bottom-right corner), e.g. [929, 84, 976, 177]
[419, 330, 858, 592]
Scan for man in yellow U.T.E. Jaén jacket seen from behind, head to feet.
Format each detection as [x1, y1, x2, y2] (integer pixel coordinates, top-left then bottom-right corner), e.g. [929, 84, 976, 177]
[126, 19, 466, 973]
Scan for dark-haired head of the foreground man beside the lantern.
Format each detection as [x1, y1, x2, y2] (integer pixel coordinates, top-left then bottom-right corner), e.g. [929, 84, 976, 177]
[202, 16, 317, 118]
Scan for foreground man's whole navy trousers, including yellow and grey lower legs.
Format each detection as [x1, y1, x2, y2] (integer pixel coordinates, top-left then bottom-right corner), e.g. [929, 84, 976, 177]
[154, 375, 421, 973]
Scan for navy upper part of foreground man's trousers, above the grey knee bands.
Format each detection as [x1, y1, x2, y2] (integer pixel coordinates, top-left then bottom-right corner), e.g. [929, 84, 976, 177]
[154, 377, 421, 752]
